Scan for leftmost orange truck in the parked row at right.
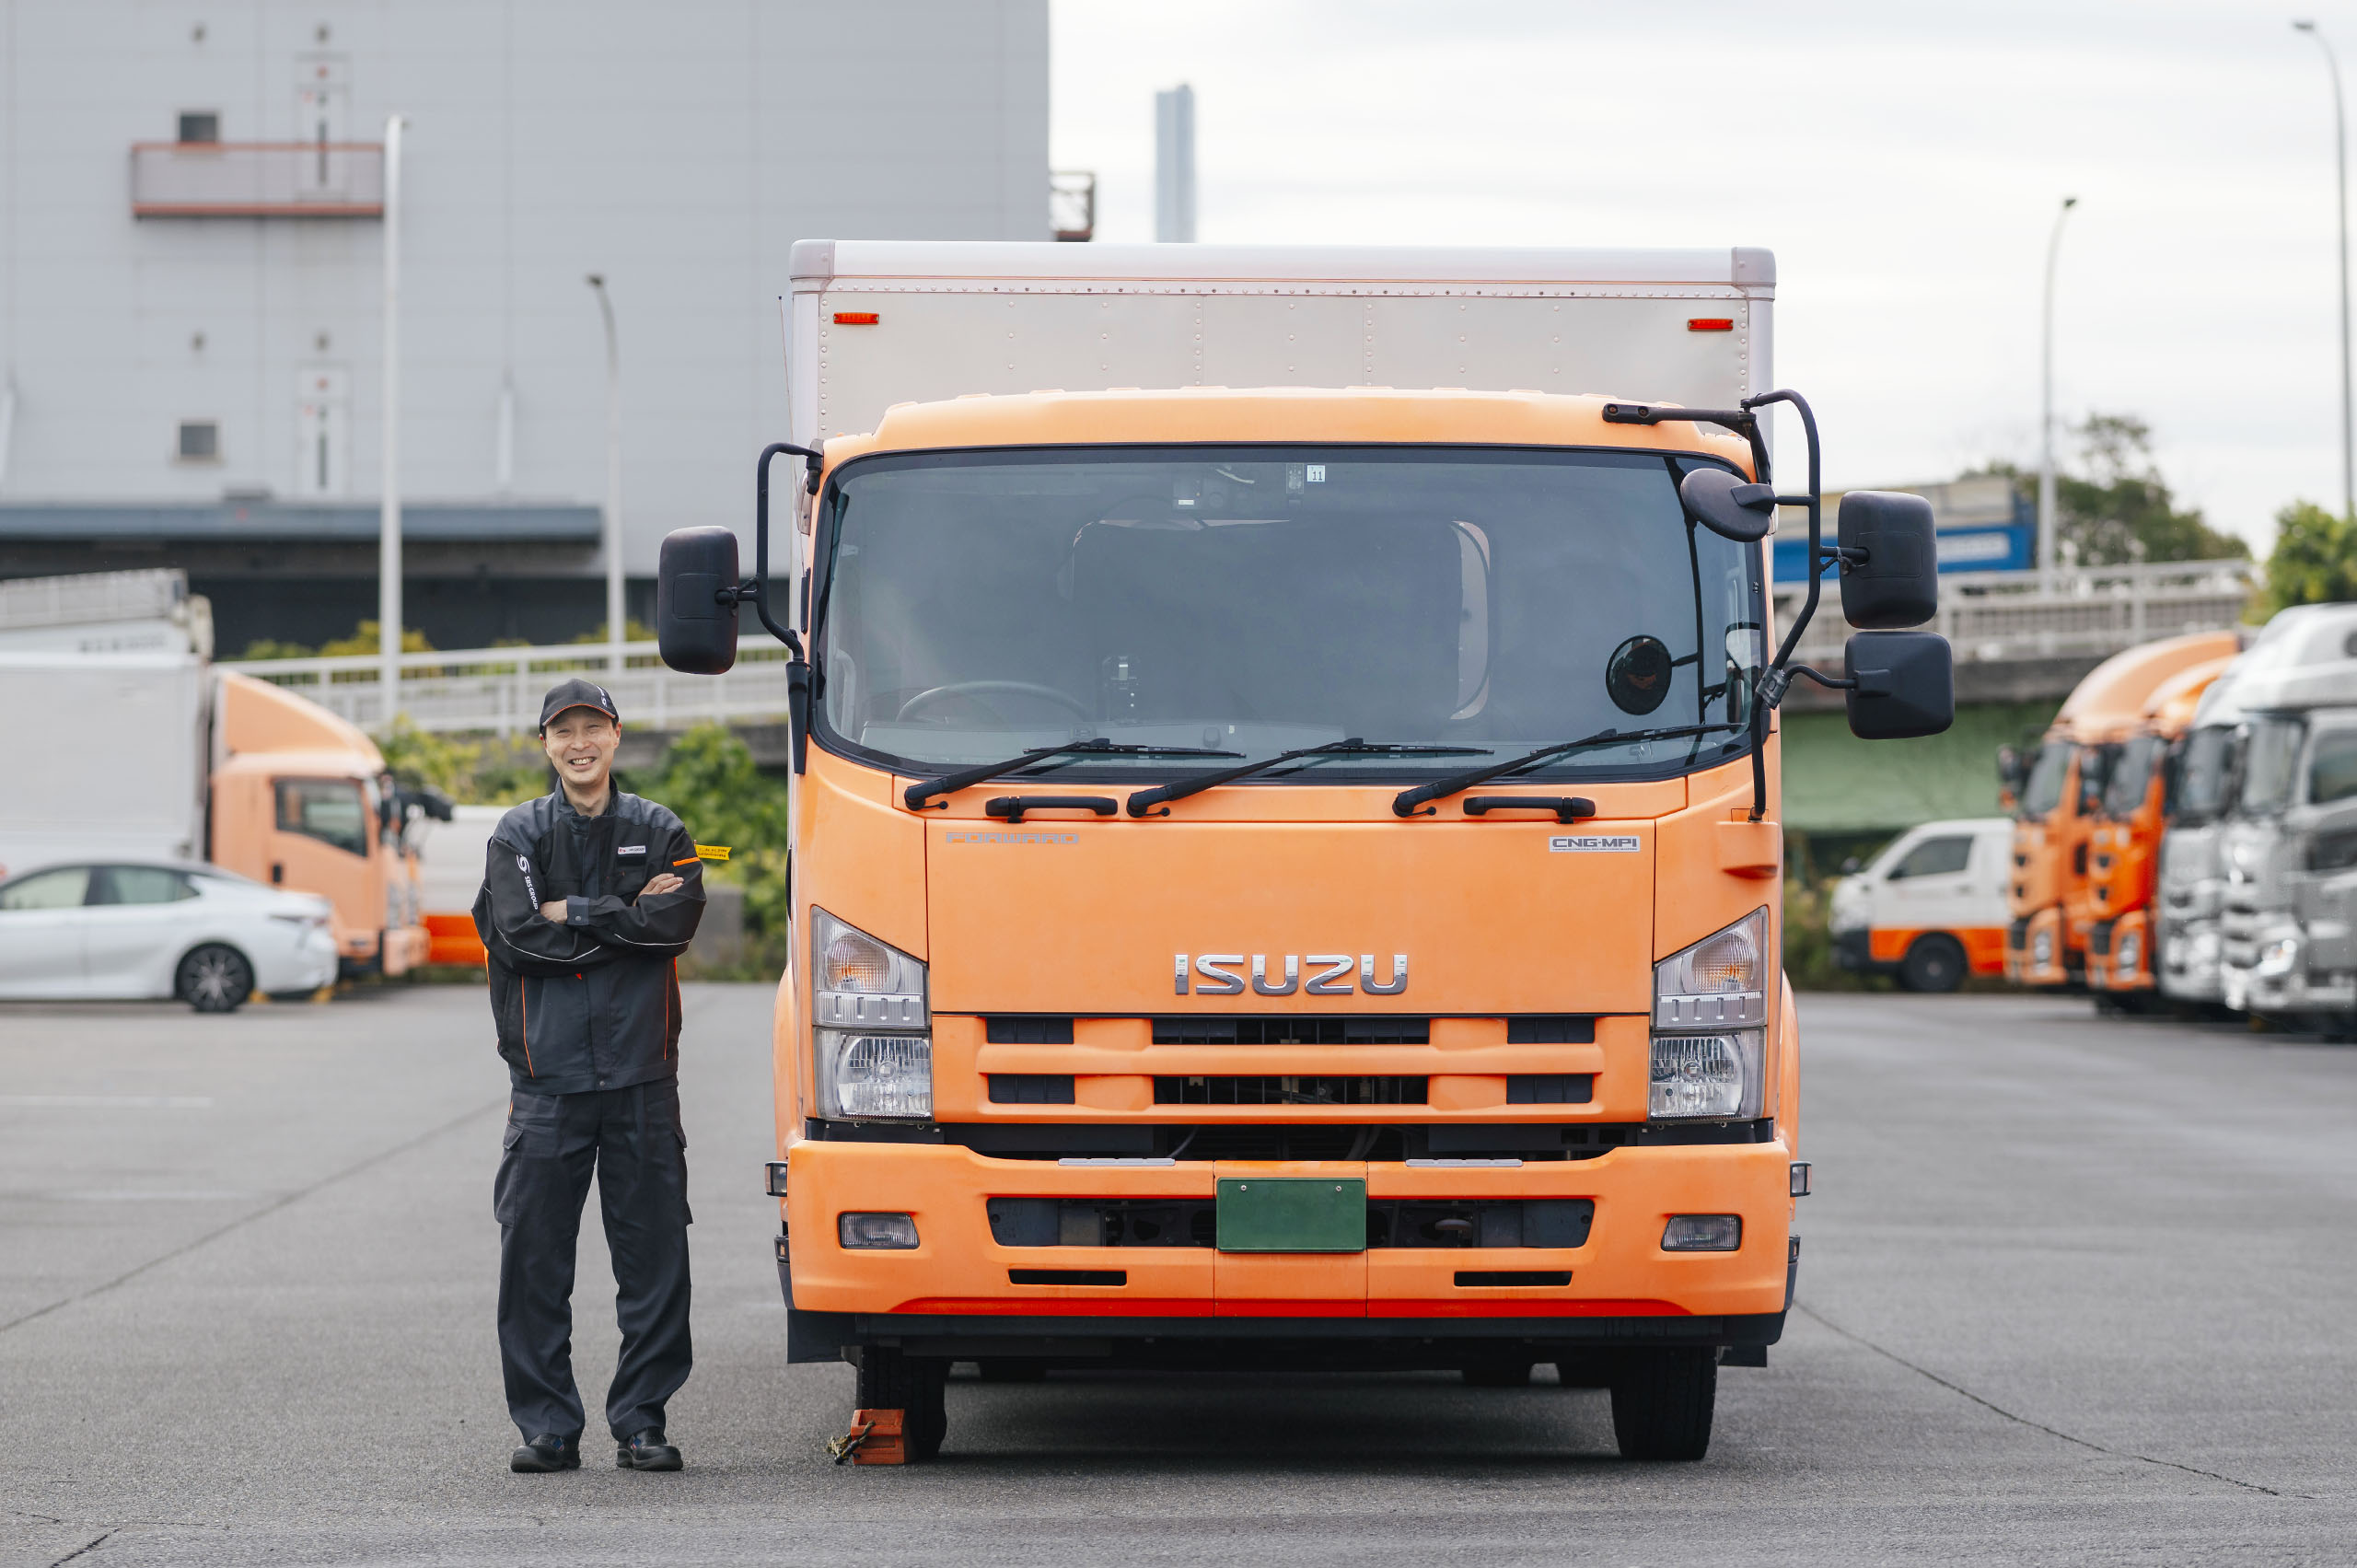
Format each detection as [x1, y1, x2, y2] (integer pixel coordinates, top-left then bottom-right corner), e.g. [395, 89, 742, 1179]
[2001, 632, 2239, 985]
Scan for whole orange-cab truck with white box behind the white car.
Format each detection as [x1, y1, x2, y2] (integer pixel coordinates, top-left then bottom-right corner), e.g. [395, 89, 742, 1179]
[0, 573, 426, 974]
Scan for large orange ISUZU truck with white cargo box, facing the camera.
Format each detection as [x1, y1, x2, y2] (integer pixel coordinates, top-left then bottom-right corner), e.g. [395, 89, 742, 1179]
[657, 240, 1954, 1459]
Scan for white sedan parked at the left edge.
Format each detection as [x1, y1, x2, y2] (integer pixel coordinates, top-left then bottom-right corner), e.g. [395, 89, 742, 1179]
[0, 861, 337, 1012]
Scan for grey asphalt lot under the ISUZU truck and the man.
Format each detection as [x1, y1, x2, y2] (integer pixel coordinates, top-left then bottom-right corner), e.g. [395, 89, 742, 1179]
[0, 985, 2357, 1568]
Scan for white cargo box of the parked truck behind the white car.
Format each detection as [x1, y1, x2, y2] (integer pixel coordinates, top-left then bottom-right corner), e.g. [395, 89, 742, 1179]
[0, 648, 215, 873]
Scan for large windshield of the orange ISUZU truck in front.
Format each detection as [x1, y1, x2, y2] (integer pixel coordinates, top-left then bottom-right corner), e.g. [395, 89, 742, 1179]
[816, 446, 1765, 781]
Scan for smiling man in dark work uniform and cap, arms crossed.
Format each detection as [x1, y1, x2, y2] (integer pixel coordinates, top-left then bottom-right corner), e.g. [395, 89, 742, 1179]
[474, 679, 704, 1471]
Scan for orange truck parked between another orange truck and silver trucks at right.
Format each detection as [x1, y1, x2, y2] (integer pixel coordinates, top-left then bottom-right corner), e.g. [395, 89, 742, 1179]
[2086, 656, 2235, 1007]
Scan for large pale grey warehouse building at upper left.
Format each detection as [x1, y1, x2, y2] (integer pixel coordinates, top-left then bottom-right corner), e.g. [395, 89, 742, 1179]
[0, 0, 1049, 656]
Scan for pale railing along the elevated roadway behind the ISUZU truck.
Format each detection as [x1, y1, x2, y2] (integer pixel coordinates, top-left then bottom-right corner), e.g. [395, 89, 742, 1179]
[224, 561, 2256, 736]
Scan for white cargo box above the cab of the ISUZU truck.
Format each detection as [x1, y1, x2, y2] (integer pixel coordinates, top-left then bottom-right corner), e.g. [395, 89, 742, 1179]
[783, 240, 1775, 467]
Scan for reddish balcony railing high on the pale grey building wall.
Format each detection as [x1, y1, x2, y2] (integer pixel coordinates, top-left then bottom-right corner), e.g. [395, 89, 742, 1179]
[132, 142, 384, 217]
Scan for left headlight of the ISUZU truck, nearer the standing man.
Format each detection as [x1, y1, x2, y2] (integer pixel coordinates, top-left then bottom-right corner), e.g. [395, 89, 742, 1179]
[811, 908, 934, 1120]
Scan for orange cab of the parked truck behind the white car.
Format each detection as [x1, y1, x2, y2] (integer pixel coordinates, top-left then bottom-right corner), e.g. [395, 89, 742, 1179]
[210, 669, 426, 976]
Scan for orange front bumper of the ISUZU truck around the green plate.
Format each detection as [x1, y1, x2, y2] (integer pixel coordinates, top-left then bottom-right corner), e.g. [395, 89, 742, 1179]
[778, 1141, 1794, 1365]
